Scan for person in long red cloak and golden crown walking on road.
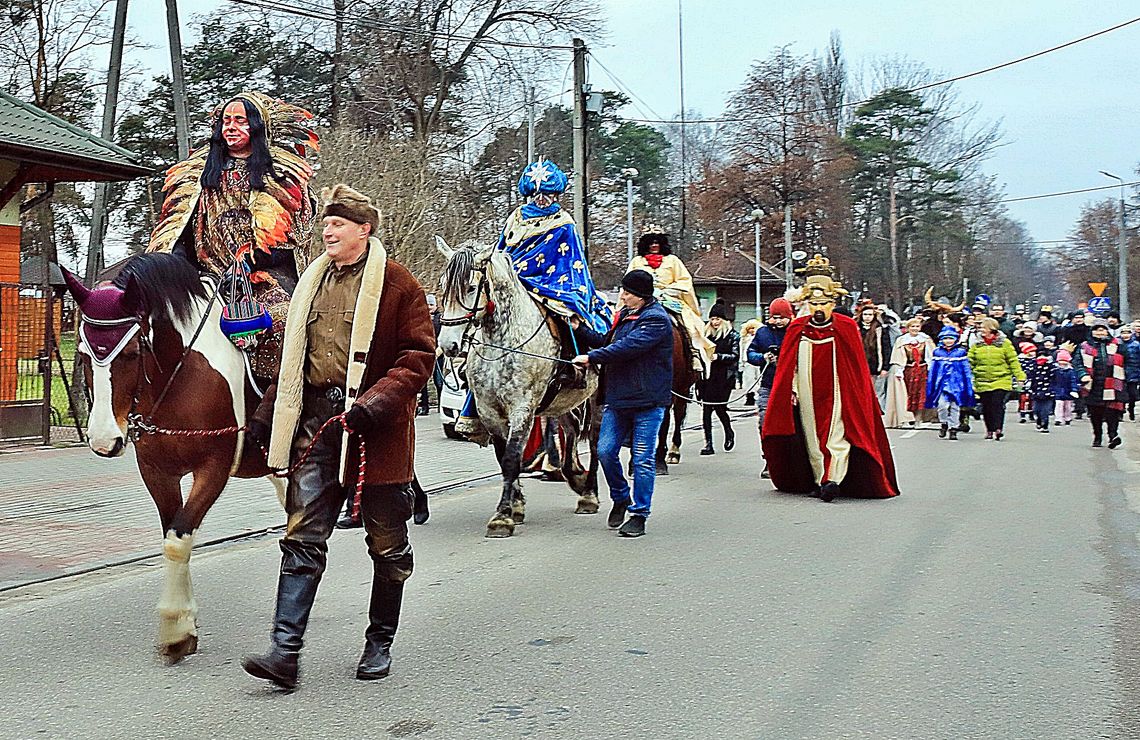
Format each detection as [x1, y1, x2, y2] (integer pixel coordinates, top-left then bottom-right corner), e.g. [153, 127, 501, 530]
[762, 266, 898, 502]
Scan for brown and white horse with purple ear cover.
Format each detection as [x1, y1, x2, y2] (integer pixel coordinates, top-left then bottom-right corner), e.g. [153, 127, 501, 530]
[66, 254, 284, 662]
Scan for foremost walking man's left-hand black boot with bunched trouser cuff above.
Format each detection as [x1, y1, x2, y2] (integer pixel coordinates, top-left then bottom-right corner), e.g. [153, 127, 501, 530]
[242, 539, 325, 690]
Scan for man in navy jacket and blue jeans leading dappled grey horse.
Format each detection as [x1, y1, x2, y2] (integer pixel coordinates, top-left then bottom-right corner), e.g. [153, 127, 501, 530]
[571, 270, 673, 537]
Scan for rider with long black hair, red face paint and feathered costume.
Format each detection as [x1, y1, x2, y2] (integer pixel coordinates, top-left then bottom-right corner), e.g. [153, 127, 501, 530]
[147, 92, 319, 375]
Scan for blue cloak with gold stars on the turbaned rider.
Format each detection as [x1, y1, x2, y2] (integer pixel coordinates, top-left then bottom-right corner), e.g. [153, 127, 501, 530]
[498, 203, 612, 333]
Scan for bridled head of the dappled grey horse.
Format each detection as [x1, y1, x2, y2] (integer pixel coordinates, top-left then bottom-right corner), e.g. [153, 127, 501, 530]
[435, 236, 514, 357]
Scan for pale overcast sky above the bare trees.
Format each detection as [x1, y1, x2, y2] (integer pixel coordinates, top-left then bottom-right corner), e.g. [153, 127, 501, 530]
[129, 0, 1140, 245]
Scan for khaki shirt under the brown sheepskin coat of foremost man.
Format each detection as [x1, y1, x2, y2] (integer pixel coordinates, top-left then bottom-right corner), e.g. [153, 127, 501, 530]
[304, 252, 368, 389]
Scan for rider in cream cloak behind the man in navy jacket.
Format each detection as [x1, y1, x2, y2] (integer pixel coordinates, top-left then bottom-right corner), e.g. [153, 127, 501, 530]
[627, 225, 716, 375]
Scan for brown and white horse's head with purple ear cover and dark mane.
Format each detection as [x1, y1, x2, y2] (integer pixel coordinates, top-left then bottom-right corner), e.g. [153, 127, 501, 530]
[64, 254, 205, 457]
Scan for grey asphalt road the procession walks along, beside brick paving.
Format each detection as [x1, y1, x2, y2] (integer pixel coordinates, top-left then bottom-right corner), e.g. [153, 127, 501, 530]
[0, 412, 1140, 739]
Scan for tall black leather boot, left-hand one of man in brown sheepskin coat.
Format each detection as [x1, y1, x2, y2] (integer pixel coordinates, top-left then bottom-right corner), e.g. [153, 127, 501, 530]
[242, 553, 320, 691]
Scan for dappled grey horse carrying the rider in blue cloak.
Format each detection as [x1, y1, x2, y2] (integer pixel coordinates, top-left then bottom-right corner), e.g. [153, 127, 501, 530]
[435, 237, 600, 537]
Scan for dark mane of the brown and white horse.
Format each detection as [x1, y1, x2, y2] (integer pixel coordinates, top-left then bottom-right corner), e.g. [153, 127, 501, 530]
[112, 252, 210, 322]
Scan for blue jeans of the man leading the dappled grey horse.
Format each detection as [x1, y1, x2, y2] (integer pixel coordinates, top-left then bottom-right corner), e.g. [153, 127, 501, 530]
[597, 406, 665, 517]
